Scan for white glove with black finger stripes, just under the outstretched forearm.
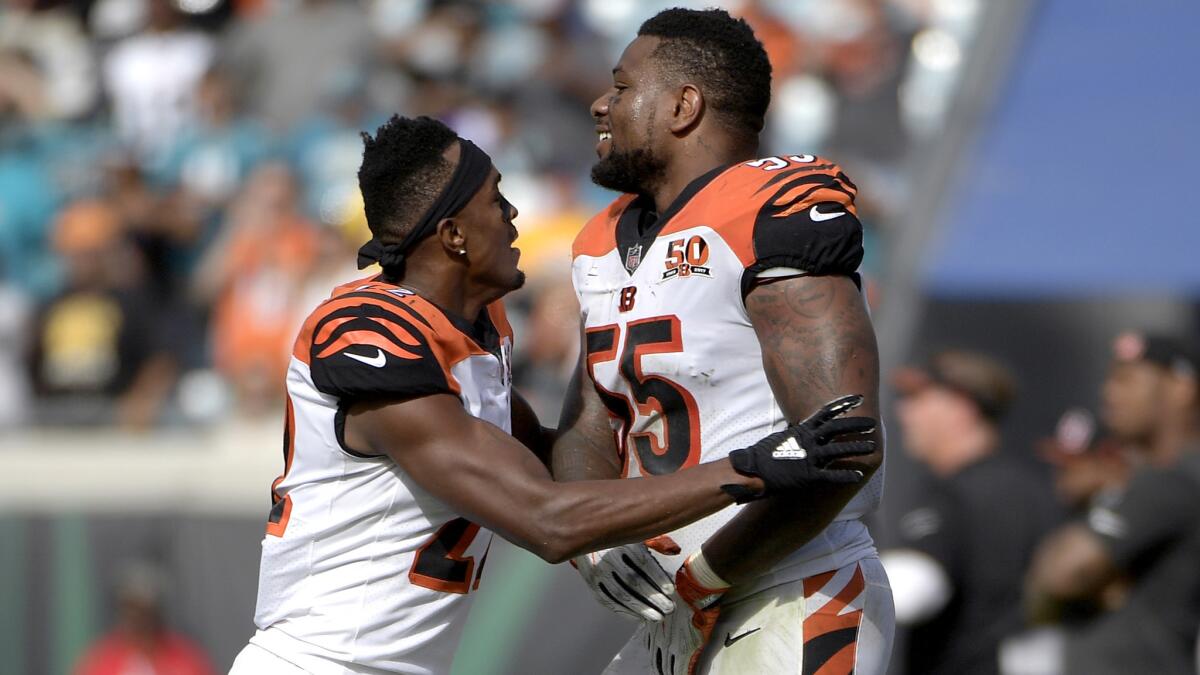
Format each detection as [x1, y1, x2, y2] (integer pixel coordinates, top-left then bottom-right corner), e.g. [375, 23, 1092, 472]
[571, 537, 679, 621]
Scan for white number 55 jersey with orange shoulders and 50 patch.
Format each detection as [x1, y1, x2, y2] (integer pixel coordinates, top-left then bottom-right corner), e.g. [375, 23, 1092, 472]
[572, 155, 883, 595]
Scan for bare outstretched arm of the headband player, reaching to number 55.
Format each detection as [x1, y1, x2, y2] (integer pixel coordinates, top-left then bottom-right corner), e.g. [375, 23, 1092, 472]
[346, 394, 748, 562]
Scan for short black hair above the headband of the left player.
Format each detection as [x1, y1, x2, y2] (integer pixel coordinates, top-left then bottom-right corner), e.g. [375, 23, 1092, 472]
[359, 115, 458, 244]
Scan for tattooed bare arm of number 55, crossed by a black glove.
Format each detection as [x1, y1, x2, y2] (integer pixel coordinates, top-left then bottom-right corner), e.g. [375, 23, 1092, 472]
[703, 276, 883, 585]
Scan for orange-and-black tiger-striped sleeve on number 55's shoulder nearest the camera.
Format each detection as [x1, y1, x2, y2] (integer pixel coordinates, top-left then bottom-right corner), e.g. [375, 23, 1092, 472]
[744, 155, 863, 292]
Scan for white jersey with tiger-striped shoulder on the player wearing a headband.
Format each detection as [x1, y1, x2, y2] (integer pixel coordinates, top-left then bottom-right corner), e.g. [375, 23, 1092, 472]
[251, 279, 512, 675]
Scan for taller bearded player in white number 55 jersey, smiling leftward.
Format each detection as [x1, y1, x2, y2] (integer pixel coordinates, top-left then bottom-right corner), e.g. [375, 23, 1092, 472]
[552, 8, 894, 674]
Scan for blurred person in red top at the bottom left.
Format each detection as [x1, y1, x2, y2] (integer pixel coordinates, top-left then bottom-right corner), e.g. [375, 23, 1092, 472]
[74, 565, 216, 675]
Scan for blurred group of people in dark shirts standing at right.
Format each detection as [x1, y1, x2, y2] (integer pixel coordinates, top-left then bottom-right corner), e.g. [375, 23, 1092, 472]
[881, 333, 1200, 675]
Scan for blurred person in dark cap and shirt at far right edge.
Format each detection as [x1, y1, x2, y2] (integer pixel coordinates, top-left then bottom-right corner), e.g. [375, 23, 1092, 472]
[1028, 333, 1200, 674]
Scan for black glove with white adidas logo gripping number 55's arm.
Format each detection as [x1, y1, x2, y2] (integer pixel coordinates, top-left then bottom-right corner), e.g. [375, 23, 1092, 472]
[721, 395, 876, 504]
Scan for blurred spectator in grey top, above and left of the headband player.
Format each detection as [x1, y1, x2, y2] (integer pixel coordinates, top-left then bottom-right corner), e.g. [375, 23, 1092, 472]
[224, 0, 374, 131]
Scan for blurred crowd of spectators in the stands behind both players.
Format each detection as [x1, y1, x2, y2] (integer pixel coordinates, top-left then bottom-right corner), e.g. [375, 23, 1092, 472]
[0, 0, 980, 429]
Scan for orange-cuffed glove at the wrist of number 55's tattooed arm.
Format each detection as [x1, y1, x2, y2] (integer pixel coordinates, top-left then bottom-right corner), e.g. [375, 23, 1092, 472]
[646, 552, 727, 675]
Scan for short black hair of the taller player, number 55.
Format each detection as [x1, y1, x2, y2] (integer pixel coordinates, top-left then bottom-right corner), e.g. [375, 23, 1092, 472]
[637, 7, 770, 135]
